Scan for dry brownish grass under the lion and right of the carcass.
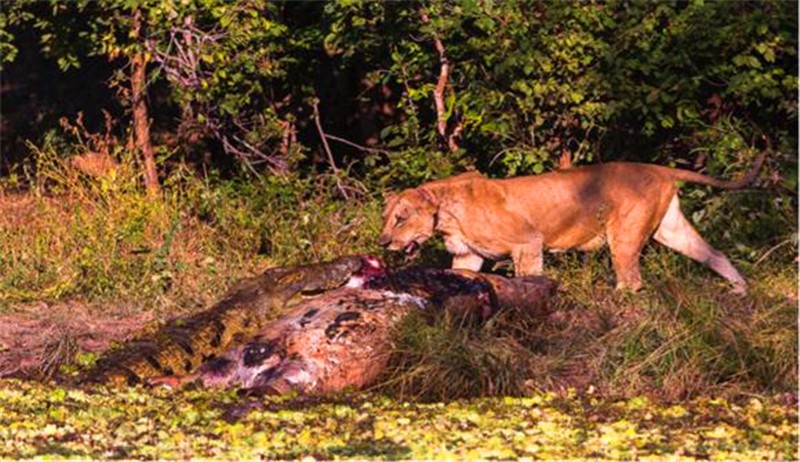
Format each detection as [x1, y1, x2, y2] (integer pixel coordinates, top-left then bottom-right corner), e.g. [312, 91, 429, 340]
[384, 248, 798, 401]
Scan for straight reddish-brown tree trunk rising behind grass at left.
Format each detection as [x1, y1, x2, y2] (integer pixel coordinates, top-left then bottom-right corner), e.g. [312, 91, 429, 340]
[131, 10, 159, 194]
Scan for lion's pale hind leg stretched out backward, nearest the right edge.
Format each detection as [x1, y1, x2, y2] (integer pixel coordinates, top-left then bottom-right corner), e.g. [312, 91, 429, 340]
[654, 194, 747, 295]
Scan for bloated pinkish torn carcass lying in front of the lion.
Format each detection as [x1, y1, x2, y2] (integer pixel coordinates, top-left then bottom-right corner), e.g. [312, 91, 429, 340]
[83, 257, 555, 393]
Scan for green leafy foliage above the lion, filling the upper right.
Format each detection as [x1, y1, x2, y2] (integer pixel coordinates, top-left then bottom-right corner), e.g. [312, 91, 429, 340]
[318, 2, 797, 178]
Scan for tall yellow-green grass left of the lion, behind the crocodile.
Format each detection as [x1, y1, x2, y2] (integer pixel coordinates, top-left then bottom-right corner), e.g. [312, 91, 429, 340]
[0, 141, 379, 311]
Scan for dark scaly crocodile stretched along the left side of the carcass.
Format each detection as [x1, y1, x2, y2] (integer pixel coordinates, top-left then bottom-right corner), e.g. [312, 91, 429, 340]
[78, 257, 363, 385]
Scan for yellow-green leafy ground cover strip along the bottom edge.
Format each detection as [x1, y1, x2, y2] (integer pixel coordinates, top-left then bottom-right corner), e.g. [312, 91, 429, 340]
[0, 380, 798, 460]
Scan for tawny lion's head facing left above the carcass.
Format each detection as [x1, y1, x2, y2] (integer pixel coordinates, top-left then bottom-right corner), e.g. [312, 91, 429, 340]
[379, 188, 437, 254]
